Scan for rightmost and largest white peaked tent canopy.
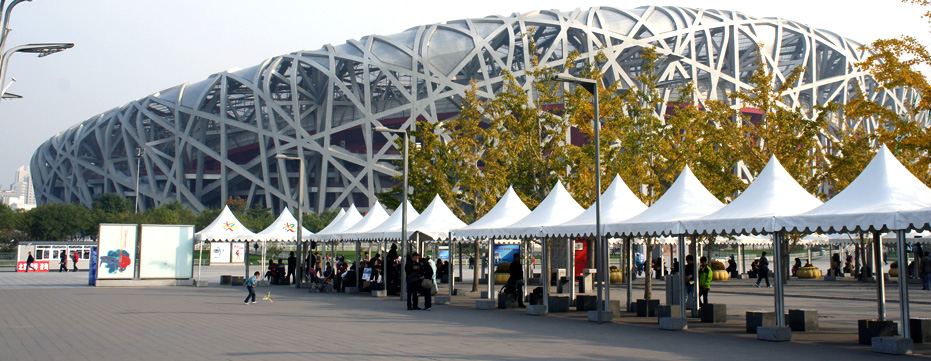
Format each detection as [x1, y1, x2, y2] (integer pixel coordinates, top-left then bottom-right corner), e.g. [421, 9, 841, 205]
[776, 145, 931, 233]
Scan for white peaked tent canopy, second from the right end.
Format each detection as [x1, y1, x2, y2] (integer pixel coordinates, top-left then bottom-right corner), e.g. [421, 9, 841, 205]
[682, 156, 822, 235]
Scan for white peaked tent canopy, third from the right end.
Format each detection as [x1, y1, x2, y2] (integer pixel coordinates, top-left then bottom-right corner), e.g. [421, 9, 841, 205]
[603, 166, 724, 237]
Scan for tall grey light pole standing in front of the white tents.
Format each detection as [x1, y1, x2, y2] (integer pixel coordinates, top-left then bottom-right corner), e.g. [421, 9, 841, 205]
[553, 73, 611, 323]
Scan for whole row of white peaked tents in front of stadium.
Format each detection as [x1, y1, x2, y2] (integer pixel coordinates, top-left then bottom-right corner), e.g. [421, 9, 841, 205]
[197, 146, 931, 335]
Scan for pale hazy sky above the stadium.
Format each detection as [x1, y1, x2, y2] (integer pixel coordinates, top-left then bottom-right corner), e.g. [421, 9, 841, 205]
[0, 0, 931, 188]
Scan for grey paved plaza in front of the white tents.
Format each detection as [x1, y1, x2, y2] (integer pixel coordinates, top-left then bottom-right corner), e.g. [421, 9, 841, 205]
[0, 266, 931, 360]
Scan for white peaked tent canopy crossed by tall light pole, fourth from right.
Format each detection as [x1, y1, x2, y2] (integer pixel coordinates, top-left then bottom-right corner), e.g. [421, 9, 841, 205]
[543, 175, 647, 237]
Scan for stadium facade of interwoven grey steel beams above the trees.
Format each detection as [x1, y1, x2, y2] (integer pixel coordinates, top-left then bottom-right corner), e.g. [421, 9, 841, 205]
[32, 6, 913, 211]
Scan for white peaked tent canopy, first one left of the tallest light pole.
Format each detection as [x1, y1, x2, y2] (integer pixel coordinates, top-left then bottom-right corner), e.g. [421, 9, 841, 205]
[474, 181, 585, 238]
